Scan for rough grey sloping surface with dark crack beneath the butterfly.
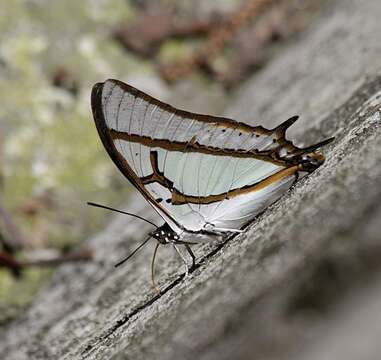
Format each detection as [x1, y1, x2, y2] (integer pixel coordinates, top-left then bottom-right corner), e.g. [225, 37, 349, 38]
[0, 0, 381, 360]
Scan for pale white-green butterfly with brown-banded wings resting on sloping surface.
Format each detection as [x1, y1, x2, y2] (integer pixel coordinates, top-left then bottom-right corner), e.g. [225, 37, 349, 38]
[91, 79, 333, 282]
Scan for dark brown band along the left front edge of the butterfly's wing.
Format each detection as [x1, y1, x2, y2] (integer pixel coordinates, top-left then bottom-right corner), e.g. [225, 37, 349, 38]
[91, 83, 183, 229]
